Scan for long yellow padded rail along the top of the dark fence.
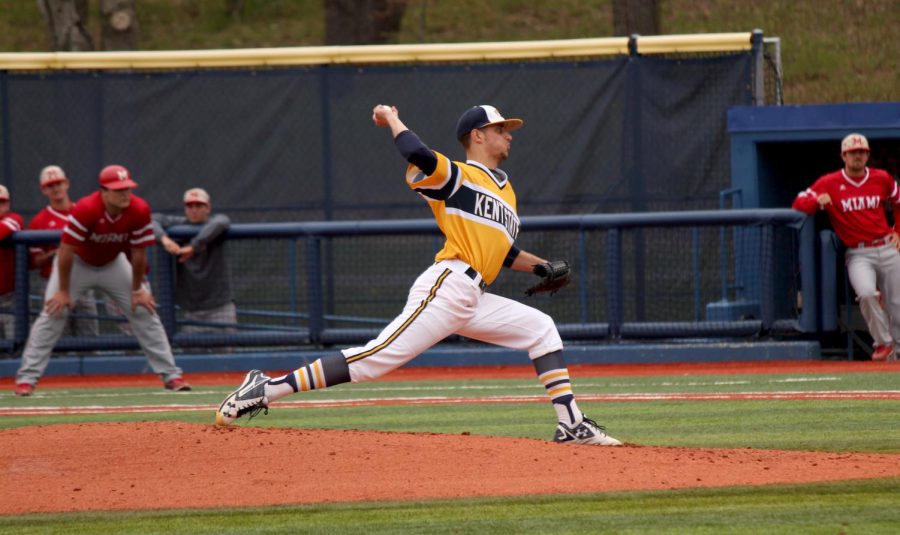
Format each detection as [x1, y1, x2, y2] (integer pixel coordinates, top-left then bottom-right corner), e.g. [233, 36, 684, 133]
[0, 32, 751, 71]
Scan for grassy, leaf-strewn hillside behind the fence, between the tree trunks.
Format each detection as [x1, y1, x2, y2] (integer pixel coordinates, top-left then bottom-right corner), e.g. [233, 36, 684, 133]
[0, 0, 900, 104]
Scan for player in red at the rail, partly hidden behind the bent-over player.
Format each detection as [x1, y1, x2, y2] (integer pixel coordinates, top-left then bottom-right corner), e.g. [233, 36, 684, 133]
[28, 165, 100, 336]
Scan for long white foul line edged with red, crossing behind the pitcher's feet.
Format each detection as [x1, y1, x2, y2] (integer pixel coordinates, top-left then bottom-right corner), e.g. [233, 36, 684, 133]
[0, 390, 900, 416]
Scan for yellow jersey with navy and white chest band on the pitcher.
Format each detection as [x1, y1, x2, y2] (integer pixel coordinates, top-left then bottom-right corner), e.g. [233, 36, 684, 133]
[406, 151, 519, 284]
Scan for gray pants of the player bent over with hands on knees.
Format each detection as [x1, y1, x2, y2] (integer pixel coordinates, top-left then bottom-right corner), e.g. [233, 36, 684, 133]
[16, 253, 181, 384]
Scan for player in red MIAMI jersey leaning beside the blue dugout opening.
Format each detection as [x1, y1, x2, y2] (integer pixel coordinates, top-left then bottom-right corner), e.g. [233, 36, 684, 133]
[793, 134, 900, 360]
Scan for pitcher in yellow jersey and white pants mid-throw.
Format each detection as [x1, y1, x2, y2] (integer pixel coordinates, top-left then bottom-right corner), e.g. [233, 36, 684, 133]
[216, 105, 621, 446]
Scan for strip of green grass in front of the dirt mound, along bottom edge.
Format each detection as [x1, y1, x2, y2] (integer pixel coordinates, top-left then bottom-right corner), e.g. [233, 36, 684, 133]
[0, 479, 900, 535]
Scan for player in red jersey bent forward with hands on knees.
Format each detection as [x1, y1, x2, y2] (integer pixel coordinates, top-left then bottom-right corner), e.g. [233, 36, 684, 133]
[16, 165, 191, 396]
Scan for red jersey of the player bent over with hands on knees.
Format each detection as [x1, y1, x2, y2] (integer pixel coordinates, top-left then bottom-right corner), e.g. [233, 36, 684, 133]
[62, 191, 156, 266]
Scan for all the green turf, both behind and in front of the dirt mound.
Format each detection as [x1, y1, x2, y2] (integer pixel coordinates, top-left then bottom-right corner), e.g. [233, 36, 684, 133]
[0, 369, 900, 534]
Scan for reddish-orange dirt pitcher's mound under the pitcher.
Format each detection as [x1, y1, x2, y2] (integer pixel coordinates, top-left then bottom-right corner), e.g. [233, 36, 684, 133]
[0, 422, 900, 514]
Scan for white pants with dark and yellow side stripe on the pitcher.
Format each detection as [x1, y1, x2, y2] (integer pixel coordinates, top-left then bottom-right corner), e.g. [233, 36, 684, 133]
[343, 260, 563, 383]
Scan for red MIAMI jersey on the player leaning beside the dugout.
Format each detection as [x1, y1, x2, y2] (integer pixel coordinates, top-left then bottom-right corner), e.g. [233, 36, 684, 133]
[793, 168, 900, 247]
